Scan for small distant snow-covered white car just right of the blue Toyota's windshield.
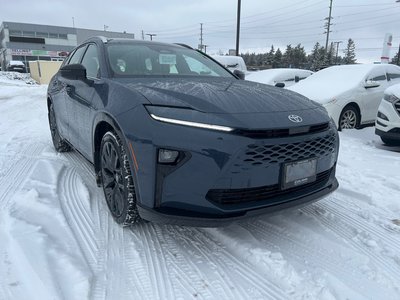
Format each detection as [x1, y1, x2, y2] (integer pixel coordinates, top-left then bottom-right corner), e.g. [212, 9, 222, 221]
[246, 68, 314, 87]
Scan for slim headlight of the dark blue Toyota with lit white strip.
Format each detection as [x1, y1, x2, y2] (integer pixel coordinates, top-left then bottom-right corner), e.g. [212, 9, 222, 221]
[145, 105, 234, 132]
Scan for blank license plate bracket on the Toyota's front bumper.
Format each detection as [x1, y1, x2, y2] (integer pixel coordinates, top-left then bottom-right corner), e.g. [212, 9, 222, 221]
[281, 158, 317, 190]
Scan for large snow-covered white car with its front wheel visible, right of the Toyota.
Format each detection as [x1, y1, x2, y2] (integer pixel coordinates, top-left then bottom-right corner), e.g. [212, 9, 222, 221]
[289, 64, 400, 130]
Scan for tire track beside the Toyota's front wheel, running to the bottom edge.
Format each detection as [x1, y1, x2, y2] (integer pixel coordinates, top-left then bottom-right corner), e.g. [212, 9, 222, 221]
[66, 152, 148, 299]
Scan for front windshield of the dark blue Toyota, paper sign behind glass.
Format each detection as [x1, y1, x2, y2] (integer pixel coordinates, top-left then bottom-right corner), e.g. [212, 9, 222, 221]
[107, 43, 232, 77]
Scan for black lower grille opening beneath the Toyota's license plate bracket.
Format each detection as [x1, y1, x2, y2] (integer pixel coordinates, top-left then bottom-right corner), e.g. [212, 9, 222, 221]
[206, 169, 332, 204]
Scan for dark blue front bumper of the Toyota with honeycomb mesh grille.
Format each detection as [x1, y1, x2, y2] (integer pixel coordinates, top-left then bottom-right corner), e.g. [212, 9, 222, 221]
[122, 106, 338, 226]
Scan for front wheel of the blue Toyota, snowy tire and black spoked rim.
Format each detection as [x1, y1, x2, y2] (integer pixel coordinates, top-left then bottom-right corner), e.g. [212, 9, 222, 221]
[100, 131, 140, 226]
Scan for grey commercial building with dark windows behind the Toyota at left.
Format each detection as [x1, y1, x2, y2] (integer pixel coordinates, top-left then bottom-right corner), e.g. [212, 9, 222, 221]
[0, 22, 135, 71]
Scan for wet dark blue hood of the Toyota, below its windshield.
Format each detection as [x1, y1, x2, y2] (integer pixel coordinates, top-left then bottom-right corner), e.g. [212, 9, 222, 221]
[120, 78, 318, 114]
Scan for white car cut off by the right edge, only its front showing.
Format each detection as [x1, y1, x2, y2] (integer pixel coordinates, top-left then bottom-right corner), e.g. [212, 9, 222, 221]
[375, 84, 400, 145]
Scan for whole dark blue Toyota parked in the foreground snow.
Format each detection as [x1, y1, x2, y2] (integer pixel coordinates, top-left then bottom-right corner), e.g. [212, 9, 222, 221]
[47, 38, 338, 226]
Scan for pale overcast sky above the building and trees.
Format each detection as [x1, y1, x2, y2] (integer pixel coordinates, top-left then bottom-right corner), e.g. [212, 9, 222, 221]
[0, 0, 400, 62]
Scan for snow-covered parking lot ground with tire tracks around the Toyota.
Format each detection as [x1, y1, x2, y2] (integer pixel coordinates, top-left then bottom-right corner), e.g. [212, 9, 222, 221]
[0, 73, 400, 299]
